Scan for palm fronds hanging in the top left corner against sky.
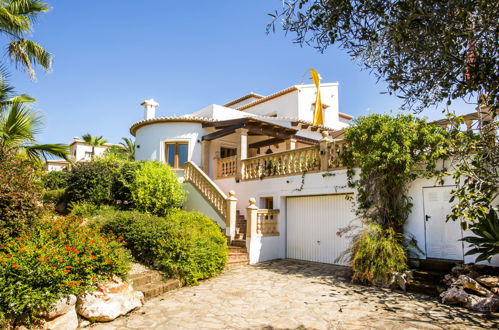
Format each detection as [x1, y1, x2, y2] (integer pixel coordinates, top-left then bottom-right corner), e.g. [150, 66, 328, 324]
[0, 0, 52, 79]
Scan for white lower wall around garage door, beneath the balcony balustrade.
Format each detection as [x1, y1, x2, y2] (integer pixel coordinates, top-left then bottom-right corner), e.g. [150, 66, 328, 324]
[215, 170, 499, 266]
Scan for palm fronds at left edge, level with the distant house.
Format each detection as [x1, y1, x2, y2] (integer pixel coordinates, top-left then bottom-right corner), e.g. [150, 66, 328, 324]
[0, 102, 69, 160]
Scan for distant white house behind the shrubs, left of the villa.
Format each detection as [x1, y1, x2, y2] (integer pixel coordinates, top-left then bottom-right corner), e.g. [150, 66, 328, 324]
[45, 136, 118, 172]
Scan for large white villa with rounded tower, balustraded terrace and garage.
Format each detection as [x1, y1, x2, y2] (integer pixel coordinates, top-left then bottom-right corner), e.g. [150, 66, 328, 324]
[130, 83, 499, 264]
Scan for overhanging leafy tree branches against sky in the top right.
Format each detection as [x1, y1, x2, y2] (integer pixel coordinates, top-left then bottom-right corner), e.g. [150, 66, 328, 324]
[269, 0, 499, 114]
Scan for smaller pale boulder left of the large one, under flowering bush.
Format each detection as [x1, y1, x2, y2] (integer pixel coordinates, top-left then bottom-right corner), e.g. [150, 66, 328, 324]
[43, 295, 78, 330]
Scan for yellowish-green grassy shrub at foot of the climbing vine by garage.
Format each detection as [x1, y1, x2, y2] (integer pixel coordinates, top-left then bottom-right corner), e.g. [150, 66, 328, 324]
[351, 225, 407, 286]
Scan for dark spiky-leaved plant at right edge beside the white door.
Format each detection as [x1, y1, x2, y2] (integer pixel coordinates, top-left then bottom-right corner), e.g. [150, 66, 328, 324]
[462, 208, 499, 262]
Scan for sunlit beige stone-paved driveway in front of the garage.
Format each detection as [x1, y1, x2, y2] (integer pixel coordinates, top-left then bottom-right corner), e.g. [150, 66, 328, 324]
[92, 260, 499, 330]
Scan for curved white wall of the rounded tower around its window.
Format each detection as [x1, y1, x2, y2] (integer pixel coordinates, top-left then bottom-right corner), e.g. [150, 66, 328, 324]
[135, 122, 206, 164]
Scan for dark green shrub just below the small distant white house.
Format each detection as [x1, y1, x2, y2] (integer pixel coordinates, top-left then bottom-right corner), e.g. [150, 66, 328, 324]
[66, 161, 114, 205]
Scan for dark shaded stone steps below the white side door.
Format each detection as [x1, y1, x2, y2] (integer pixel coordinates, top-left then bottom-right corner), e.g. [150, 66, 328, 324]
[406, 259, 462, 297]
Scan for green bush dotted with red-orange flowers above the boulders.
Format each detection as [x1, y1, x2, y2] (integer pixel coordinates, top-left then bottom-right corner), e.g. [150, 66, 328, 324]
[0, 217, 131, 323]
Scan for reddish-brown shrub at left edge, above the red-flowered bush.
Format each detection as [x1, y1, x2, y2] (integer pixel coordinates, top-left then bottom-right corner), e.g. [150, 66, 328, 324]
[0, 156, 44, 242]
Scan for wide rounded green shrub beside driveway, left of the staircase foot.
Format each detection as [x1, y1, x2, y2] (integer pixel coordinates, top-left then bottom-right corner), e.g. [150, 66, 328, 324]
[100, 211, 227, 285]
